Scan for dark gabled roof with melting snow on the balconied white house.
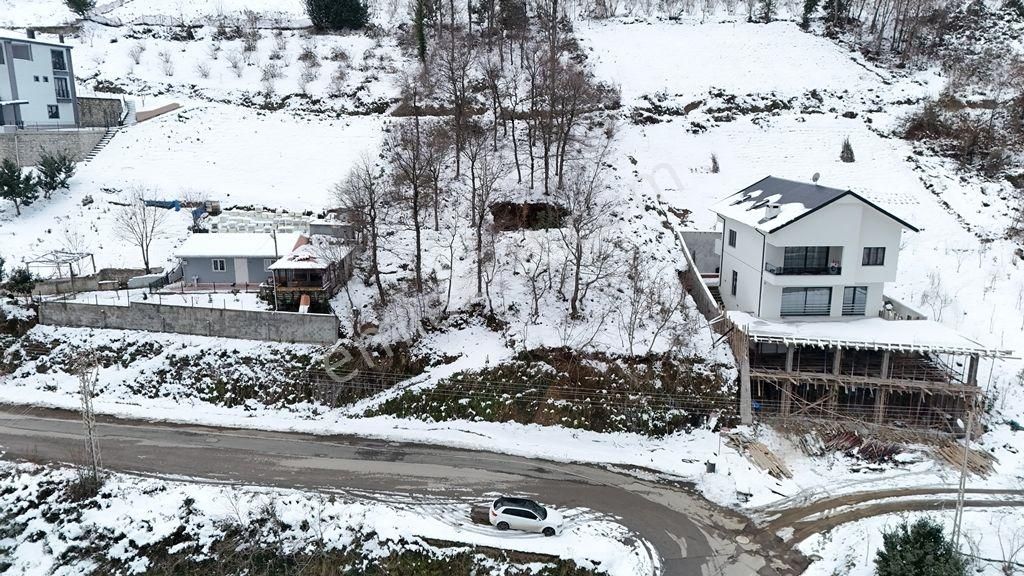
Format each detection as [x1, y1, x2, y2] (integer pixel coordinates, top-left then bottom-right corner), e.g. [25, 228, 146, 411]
[711, 176, 918, 234]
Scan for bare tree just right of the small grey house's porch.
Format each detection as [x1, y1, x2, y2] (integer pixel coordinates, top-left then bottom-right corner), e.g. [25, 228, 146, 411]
[334, 156, 388, 305]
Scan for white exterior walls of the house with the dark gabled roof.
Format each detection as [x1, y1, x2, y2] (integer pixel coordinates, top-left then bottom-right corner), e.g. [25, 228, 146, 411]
[720, 196, 903, 319]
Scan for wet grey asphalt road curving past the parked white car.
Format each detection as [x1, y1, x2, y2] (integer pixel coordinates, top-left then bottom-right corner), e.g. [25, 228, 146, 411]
[0, 406, 805, 576]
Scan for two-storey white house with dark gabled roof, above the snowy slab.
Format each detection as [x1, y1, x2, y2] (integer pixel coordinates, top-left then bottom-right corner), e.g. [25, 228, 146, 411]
[712, 176, 918, 319]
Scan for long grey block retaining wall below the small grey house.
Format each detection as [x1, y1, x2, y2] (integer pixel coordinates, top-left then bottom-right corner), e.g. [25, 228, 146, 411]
[39, 301, 338, 345]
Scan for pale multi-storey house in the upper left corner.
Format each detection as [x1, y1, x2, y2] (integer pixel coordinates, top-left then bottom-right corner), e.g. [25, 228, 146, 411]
[0, 30, 79, 131]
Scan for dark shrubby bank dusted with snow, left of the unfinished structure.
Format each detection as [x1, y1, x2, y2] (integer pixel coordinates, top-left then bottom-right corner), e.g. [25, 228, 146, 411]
[370, 348, 735, 436]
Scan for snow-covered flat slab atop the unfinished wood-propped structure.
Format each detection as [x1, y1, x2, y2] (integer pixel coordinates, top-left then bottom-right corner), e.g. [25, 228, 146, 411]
[726, 311, 1013, 358]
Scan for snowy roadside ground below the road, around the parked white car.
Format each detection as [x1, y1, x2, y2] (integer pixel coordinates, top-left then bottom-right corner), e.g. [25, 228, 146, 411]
[0, 462, 654, 576]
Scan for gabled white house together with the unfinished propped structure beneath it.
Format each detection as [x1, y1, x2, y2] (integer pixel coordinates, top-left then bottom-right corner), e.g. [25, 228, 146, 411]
[680, 177, 1011, 434]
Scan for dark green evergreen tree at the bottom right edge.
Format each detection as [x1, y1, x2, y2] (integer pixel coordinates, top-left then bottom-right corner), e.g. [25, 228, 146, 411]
[874, 519, 967, 576]
